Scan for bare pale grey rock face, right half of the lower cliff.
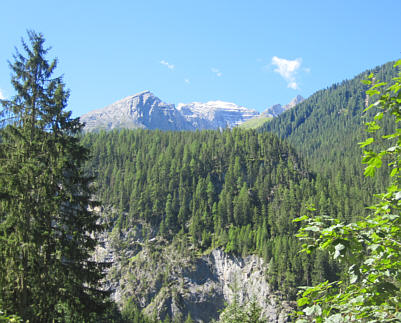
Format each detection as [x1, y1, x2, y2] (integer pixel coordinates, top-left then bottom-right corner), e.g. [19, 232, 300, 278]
[180, 249, 292, 323]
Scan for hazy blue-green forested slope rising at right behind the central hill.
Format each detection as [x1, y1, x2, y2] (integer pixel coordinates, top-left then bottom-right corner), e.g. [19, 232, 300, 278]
[262, 62, 397, 195]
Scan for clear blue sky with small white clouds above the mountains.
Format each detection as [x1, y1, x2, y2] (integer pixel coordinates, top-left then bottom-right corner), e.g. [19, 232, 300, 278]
[0, 0, 401, 116]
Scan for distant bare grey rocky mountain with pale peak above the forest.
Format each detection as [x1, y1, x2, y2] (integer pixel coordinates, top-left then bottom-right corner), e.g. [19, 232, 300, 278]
[81, 91, 259, 131]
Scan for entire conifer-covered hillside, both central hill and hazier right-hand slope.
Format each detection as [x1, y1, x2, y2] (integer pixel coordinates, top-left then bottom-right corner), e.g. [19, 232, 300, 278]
[76, 63, 396, 322]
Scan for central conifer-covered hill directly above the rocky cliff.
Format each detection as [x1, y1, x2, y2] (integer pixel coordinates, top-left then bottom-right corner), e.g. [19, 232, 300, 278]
[83, 129, 365, 306]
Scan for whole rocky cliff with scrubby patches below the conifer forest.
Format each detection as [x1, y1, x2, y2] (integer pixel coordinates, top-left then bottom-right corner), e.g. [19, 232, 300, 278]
[96, 213, 292, 322]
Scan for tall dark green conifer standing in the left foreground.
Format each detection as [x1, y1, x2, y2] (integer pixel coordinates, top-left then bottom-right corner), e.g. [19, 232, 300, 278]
[0, 31, 107, 322]
